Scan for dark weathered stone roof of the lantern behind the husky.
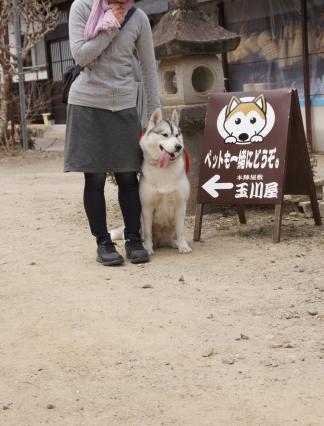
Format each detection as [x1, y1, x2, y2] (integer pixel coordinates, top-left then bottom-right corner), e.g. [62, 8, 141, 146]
[153, 0, 240, 59]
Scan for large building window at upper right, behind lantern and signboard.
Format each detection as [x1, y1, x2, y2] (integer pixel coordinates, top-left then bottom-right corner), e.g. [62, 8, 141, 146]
[225, 0, 324, 103]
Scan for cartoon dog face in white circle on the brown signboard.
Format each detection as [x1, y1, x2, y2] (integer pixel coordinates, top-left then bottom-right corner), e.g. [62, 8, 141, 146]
[217, 94, 275, 145]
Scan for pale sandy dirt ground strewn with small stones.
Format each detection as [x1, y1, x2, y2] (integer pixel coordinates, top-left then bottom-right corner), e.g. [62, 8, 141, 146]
[0, 153, 324, 426]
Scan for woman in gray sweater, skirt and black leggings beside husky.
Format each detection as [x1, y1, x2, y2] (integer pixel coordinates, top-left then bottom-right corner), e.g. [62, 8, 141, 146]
[64, 0, 160, 266]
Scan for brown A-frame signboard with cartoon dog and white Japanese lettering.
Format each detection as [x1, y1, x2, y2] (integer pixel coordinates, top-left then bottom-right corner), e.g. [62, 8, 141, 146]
[194, 90, 321, 242]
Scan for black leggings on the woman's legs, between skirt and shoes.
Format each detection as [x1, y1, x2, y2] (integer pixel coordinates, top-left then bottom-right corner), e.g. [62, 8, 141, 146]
[83, 172, 141, 243]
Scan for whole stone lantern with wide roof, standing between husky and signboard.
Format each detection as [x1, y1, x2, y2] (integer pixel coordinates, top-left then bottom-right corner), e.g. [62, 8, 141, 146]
[153, 0, 240, 214]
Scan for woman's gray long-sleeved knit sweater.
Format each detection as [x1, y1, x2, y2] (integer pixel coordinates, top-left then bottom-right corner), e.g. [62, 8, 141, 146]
[68, 0, 161, 120]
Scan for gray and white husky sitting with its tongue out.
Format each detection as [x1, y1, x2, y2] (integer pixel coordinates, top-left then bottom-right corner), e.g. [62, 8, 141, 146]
[139, 109, 191, 254]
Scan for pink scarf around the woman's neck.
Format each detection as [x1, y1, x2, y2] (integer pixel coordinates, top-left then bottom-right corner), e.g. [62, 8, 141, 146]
[84, 0, 134, 41]
